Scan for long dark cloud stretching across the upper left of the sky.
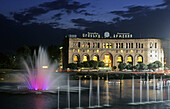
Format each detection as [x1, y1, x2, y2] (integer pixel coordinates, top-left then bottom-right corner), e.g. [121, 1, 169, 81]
[13, 0, 92, 23]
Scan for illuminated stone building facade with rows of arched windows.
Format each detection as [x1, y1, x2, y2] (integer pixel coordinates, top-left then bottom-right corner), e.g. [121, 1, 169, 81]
[63, 38, 164, 68]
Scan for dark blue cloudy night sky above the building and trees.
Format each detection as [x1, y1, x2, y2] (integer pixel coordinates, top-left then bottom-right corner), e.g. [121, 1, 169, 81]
[0, 0, 170, 52]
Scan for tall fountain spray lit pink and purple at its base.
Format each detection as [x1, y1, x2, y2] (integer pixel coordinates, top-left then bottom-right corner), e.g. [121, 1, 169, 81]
[23, 47, 59, 90]
